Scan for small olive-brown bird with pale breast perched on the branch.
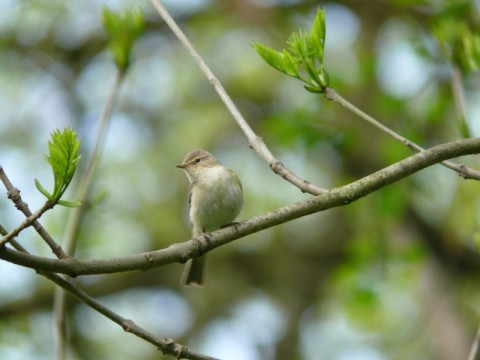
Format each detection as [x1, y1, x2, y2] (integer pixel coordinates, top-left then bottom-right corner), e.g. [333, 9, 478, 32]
[177, 149, 243, 285]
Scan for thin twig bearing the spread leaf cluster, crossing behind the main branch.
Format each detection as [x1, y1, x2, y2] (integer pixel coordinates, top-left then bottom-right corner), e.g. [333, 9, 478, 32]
[325, 88, 480, 180]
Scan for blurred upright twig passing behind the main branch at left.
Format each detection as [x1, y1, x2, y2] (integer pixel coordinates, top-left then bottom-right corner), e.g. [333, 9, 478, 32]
[53, 69, 124, 360]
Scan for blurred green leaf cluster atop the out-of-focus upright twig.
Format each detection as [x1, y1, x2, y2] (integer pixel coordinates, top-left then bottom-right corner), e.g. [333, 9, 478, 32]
[103, 8, 144, 72]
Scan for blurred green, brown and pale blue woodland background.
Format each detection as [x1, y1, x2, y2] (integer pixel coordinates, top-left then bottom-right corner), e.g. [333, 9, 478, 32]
[0, 0, 480, 360]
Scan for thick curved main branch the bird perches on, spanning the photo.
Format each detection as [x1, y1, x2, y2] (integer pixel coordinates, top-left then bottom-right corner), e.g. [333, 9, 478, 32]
[0, 138, 480, 276]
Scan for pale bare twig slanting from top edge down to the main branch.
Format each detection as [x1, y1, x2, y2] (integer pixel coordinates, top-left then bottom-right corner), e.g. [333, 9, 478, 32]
[146, 0, 326, 195]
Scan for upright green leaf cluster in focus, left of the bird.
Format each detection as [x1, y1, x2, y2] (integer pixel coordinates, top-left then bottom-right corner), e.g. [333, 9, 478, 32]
[35, 129, 81, 207]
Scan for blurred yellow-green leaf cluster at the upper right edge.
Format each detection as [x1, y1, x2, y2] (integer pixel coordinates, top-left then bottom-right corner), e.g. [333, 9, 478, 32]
[433, 18, 480, 72]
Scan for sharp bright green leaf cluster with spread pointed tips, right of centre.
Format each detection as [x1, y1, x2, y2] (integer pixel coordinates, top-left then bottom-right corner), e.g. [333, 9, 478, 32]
[252, 9, 329, 93]
